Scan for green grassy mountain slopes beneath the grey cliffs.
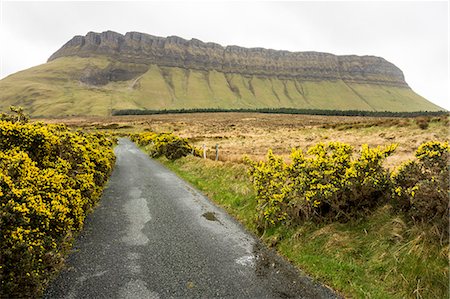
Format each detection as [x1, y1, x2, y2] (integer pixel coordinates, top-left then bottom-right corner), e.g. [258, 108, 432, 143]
[0, 57, 442, 116]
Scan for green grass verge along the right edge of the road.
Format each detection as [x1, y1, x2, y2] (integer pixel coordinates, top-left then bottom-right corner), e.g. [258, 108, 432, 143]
[156, 157, 449, 298]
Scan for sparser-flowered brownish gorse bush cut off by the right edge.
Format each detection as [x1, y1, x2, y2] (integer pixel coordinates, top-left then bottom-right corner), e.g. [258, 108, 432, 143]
[393, 141, 450, 243]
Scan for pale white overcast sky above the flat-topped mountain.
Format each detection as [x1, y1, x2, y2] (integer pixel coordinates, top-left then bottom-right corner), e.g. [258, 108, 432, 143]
[0, 0, 450, 110]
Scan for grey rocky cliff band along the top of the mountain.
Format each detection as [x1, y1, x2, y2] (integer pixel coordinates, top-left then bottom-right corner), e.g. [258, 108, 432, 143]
[49, 31, 408, 87]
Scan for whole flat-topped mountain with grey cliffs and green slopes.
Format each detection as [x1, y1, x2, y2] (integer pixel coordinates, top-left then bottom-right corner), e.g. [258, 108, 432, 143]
[0, 31, 443, 116]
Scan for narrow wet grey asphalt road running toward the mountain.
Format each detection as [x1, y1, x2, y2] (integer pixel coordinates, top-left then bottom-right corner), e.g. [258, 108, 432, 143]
[44, 139, 342, 299]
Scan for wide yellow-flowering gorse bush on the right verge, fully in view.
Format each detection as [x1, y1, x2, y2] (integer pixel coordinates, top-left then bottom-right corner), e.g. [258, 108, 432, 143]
[246, 142, 396, 229]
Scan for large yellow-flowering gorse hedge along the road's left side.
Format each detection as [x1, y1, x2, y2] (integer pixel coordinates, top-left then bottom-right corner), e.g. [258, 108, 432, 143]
[0, 118, 115, 298]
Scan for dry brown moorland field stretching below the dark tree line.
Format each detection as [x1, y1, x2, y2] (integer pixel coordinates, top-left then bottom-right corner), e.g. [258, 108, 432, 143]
[38, 113, 449, 168]
